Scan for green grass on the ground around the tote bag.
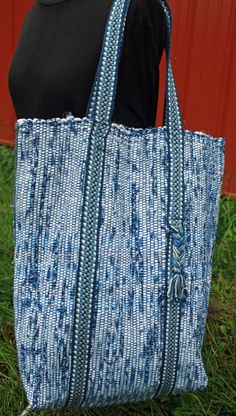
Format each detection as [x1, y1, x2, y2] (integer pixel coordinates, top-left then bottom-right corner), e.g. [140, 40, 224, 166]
[0, 145, 236, 416]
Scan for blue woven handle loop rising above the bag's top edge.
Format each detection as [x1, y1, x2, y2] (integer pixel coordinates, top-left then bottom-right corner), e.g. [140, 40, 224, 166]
[86, 0, 183, 133]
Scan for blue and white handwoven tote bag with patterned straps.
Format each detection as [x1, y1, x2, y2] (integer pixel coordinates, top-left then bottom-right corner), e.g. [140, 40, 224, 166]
[14, 0, 225, 415]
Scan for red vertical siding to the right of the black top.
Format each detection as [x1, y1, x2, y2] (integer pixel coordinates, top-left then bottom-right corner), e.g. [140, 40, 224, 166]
[156, 0, 236, 195]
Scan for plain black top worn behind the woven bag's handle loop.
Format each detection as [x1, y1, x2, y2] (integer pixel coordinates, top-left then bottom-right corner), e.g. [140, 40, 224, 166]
[8, 0, 167, 128]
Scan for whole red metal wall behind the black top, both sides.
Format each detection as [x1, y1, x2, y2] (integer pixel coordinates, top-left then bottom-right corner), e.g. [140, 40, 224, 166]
[0, 0, 236, 195]
